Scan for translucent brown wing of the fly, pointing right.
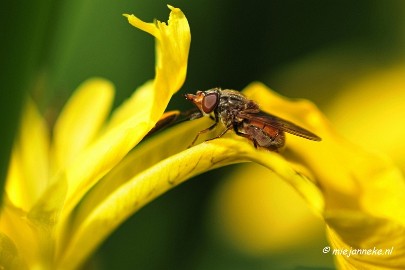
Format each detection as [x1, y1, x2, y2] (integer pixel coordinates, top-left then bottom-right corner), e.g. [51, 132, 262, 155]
[238, 111, 322, 141]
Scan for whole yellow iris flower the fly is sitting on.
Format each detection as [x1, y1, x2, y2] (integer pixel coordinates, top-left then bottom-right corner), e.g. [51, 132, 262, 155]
[0, 3, 405, 269]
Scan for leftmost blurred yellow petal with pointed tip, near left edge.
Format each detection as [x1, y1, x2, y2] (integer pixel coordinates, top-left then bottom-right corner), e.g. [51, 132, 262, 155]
[6, 100, 50, 210]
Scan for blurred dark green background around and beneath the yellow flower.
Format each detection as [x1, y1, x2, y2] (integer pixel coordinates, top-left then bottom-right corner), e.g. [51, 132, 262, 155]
[0, 0, 405, 270]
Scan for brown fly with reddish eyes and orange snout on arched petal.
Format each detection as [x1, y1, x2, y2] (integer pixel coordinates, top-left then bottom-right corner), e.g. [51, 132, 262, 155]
[185, 88, 321, 151]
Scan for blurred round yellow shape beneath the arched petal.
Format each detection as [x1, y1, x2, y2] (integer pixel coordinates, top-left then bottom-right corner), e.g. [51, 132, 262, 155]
[209, 164, 326, 256]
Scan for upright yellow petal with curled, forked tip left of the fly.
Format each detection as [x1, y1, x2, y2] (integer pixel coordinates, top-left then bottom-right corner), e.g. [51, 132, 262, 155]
[57, 8, 190, 226]
